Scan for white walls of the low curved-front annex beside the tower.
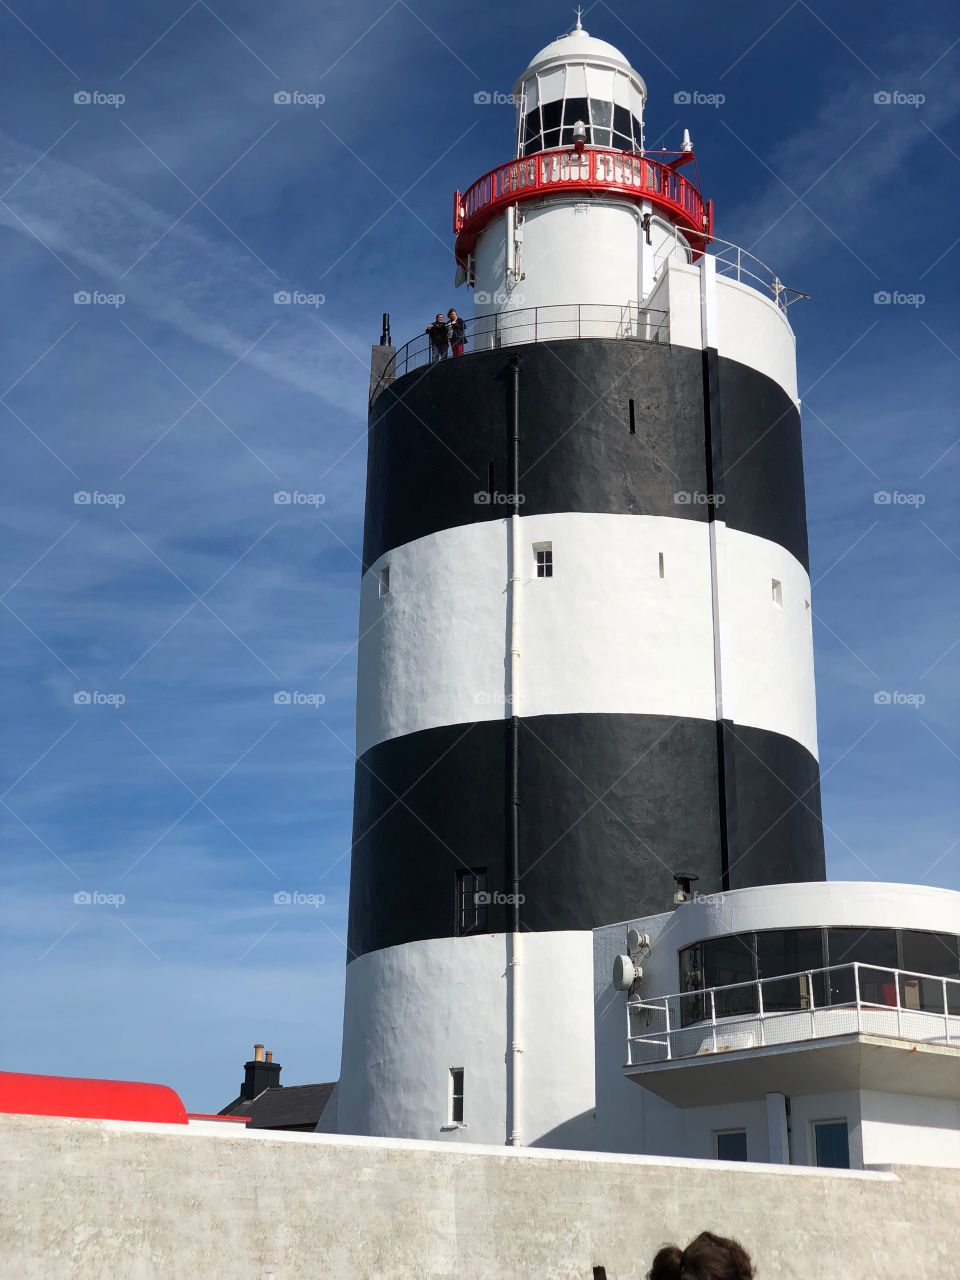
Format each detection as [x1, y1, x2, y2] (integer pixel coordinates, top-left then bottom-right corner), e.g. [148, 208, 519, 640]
[594, 881, 960, 1165]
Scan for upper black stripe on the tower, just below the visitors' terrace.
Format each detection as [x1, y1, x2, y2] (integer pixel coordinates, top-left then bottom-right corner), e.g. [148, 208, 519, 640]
[364, 339, 808, 568]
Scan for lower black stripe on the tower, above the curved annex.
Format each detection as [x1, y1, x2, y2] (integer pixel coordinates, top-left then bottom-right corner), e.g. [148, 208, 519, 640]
[348, 714, 824, 957]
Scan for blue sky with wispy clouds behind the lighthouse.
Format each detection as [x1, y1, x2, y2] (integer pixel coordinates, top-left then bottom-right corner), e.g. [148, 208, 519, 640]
[0, 0, 960, 1111]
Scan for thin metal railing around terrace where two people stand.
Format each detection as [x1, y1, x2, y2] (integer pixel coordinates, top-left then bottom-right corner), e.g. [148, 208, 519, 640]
[370, 302, 669, 403]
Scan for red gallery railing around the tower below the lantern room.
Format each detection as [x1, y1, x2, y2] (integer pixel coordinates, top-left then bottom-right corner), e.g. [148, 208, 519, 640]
[453, 147, 713, 266]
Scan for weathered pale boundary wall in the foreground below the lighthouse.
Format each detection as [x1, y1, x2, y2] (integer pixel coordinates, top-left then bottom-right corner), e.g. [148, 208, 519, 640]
[0, 1116, 960, 1280]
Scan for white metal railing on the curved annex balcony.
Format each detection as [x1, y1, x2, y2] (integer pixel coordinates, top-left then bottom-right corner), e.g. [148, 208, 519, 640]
[627, 963, 960, 1066]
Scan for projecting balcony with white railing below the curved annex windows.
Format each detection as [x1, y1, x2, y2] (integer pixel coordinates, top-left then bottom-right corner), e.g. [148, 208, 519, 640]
[623, 964, 960, 1107]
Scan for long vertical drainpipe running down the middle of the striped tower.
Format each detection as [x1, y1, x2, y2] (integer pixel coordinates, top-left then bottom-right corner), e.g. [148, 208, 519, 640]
[507, 356, 524, 1147]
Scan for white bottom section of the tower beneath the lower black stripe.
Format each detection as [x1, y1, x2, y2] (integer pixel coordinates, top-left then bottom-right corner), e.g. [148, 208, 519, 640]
[337, 931, 594, 1148]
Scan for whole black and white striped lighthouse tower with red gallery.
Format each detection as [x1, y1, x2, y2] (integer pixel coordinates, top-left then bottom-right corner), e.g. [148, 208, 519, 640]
[338, 22, 824, 1147]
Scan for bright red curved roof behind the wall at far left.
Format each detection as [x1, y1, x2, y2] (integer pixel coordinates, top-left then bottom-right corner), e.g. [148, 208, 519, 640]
[0, 1071, 187, 1124]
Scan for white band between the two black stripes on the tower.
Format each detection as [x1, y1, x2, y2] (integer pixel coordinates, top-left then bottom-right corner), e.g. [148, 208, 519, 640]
[357, 512, 817, 755]
